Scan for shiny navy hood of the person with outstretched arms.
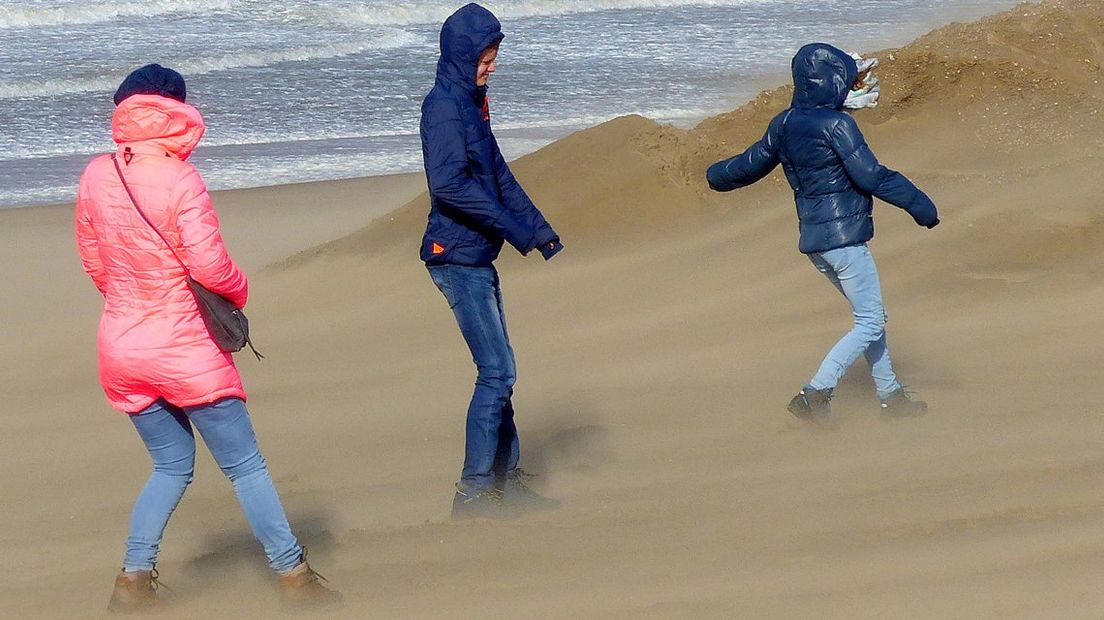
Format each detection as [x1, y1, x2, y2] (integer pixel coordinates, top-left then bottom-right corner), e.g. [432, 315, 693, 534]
[790, 43, 859, 110]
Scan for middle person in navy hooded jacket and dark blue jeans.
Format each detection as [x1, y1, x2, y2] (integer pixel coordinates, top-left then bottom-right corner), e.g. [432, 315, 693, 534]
[422, 3, 563, 519]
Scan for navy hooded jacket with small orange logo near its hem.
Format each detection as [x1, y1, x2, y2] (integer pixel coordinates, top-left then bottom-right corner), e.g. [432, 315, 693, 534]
[422, 3, 558, 267]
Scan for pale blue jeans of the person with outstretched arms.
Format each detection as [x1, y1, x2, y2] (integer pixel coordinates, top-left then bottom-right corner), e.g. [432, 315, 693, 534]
[806, 244, 901, 398]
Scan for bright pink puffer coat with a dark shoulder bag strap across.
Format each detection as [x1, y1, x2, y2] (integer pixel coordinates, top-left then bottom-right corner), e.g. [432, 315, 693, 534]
[76, 95, 248, 414]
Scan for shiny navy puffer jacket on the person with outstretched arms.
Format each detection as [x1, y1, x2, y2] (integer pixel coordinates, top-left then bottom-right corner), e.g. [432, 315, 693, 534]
[707, 43, 938, 254]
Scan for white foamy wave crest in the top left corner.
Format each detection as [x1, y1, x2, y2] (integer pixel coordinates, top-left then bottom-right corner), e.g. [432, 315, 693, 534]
[0, 0, 238, 29]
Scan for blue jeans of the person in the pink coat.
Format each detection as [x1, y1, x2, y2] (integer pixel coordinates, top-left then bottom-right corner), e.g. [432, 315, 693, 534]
[123, 398, 302, 573]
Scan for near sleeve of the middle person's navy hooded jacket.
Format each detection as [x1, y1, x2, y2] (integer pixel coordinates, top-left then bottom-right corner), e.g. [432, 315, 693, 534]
[422, 99, 537, 254]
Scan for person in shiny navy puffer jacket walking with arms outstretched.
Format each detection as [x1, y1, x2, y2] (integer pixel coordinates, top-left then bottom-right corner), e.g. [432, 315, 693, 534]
[707, 43, 940, 421]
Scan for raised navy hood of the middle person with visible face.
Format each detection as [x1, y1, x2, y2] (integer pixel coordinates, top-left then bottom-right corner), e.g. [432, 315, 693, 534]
[437, 2, 505, 96]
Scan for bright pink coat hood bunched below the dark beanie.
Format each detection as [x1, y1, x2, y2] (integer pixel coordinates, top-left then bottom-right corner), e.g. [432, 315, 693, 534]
[112, 95, 206, 160]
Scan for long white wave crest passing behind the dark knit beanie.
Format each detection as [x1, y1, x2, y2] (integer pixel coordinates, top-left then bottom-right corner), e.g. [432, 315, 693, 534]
[0, 29, 421, 99]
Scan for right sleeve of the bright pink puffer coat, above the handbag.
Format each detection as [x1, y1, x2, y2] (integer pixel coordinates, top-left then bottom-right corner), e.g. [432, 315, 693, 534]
[176, 165, 250, 308]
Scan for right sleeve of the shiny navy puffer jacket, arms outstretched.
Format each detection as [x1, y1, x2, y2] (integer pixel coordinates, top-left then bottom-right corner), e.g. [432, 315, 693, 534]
[830, 115, 938, 227]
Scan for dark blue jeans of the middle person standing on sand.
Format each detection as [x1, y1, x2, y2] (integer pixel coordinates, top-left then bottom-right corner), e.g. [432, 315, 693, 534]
[428, 265, 521, 489]
